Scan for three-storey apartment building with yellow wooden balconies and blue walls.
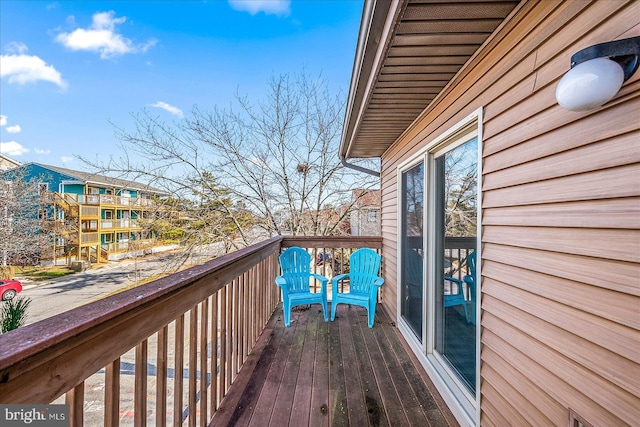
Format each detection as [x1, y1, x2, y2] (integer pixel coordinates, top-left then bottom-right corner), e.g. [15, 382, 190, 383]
[21, 163, 168, 263]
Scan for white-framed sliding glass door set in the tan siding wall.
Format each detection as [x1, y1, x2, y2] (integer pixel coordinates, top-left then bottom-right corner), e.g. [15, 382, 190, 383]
[398, 110, 482, 419]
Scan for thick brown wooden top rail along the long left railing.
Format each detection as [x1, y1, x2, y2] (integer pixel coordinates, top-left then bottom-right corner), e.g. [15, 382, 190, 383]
[0, 236, 283, 403]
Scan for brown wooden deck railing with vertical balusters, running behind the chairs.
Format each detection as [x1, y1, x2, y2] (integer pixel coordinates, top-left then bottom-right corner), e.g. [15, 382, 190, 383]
[0, 237, 381, 426]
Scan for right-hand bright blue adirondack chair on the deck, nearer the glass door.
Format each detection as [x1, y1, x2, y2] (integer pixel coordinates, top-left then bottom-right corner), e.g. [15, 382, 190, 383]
[331, 248, 384, 328]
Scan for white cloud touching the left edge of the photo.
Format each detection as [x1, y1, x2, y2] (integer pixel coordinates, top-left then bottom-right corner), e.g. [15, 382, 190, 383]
[0, 43, 67, 88]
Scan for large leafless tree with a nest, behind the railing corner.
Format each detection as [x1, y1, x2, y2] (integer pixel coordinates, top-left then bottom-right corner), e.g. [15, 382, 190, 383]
[83, 69, 377, 248]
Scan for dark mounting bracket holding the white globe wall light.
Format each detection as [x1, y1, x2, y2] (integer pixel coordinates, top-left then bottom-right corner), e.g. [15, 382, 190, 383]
[571, 37, 640, 81]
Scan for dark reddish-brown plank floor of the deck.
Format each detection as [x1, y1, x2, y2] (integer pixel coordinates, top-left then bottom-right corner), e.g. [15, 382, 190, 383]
[210, 304, 457, 427]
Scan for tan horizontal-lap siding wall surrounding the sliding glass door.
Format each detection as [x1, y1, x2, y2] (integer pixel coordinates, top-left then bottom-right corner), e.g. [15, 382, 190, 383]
[381, 0, 640, 426]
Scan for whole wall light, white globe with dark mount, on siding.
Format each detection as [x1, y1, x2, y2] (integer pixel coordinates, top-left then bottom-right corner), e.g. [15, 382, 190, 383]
[556, 37, 640, 111]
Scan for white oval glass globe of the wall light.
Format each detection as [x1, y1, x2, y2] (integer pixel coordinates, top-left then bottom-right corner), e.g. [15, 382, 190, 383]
[556, 58, 624, 111]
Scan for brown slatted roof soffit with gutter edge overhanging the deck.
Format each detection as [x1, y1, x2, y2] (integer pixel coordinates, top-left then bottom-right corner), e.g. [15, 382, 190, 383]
[340, 0, 518, 158]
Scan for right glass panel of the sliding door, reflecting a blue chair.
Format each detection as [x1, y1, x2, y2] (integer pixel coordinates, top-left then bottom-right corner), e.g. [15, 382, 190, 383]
[434, 138, 478, 395]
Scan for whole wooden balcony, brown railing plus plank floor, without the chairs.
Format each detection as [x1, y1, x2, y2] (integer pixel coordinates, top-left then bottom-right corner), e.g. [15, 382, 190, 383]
[0, 237, 455, 426]
